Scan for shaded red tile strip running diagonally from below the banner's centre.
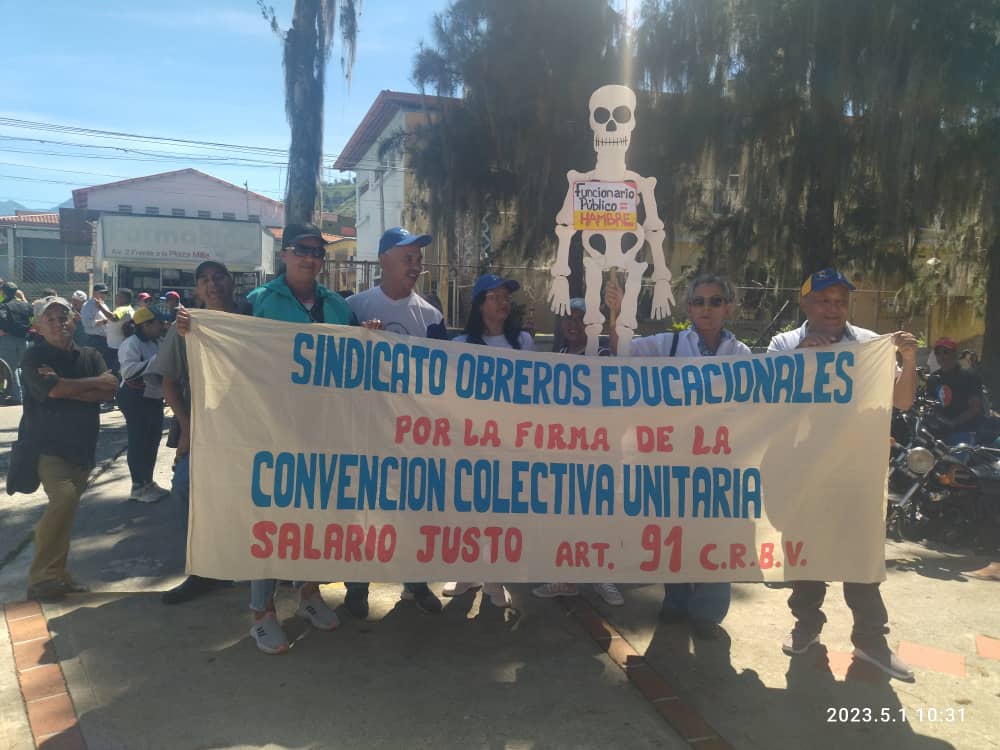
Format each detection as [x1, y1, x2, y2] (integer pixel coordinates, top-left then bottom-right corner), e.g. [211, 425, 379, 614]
[558, 598, 732, 750]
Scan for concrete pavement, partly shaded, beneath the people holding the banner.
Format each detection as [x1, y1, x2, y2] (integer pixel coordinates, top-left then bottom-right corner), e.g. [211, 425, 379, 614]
[0, 418, 1000, 750]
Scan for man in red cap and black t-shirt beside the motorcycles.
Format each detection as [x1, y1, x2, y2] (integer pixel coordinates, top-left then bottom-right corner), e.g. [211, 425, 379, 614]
[927, 336, 983, 445]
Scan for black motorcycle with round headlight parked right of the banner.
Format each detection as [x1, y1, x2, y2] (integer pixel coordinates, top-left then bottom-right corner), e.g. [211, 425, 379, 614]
[886, 397, 1000, 553]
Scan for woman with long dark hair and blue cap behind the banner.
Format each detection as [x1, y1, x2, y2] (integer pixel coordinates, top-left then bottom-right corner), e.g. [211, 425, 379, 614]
[443, 273, 535, 607]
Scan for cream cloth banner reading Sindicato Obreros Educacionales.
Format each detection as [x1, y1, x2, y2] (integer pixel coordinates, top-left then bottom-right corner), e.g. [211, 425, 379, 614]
[187, 311, 895, 582]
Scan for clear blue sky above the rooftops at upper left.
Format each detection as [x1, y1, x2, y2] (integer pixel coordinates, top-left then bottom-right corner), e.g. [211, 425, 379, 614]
[0, 0, 448, 210]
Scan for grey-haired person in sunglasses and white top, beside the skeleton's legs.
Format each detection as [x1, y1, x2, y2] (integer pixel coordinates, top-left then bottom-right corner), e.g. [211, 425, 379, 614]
[604, 274, 751, 639]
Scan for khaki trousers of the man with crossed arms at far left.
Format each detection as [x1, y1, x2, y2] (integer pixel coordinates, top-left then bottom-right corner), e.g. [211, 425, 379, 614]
[28, 455, 90, 586]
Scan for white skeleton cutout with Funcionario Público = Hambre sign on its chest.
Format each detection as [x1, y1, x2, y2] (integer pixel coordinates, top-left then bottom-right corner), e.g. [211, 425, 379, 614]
[549, 86, 674, 356]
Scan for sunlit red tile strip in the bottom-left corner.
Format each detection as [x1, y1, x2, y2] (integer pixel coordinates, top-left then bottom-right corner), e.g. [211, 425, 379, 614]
[4, 602, 87, 750]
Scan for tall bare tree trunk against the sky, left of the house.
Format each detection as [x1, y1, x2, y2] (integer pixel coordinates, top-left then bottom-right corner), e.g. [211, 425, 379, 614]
[285, 0, 326, 224]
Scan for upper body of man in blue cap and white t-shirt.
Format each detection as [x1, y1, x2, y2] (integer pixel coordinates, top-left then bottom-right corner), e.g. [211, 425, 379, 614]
[347, 227, 448, 339]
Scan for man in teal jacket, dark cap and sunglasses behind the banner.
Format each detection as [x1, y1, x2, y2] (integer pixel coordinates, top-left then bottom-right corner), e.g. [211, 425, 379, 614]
[247, 224, 353, 654]
